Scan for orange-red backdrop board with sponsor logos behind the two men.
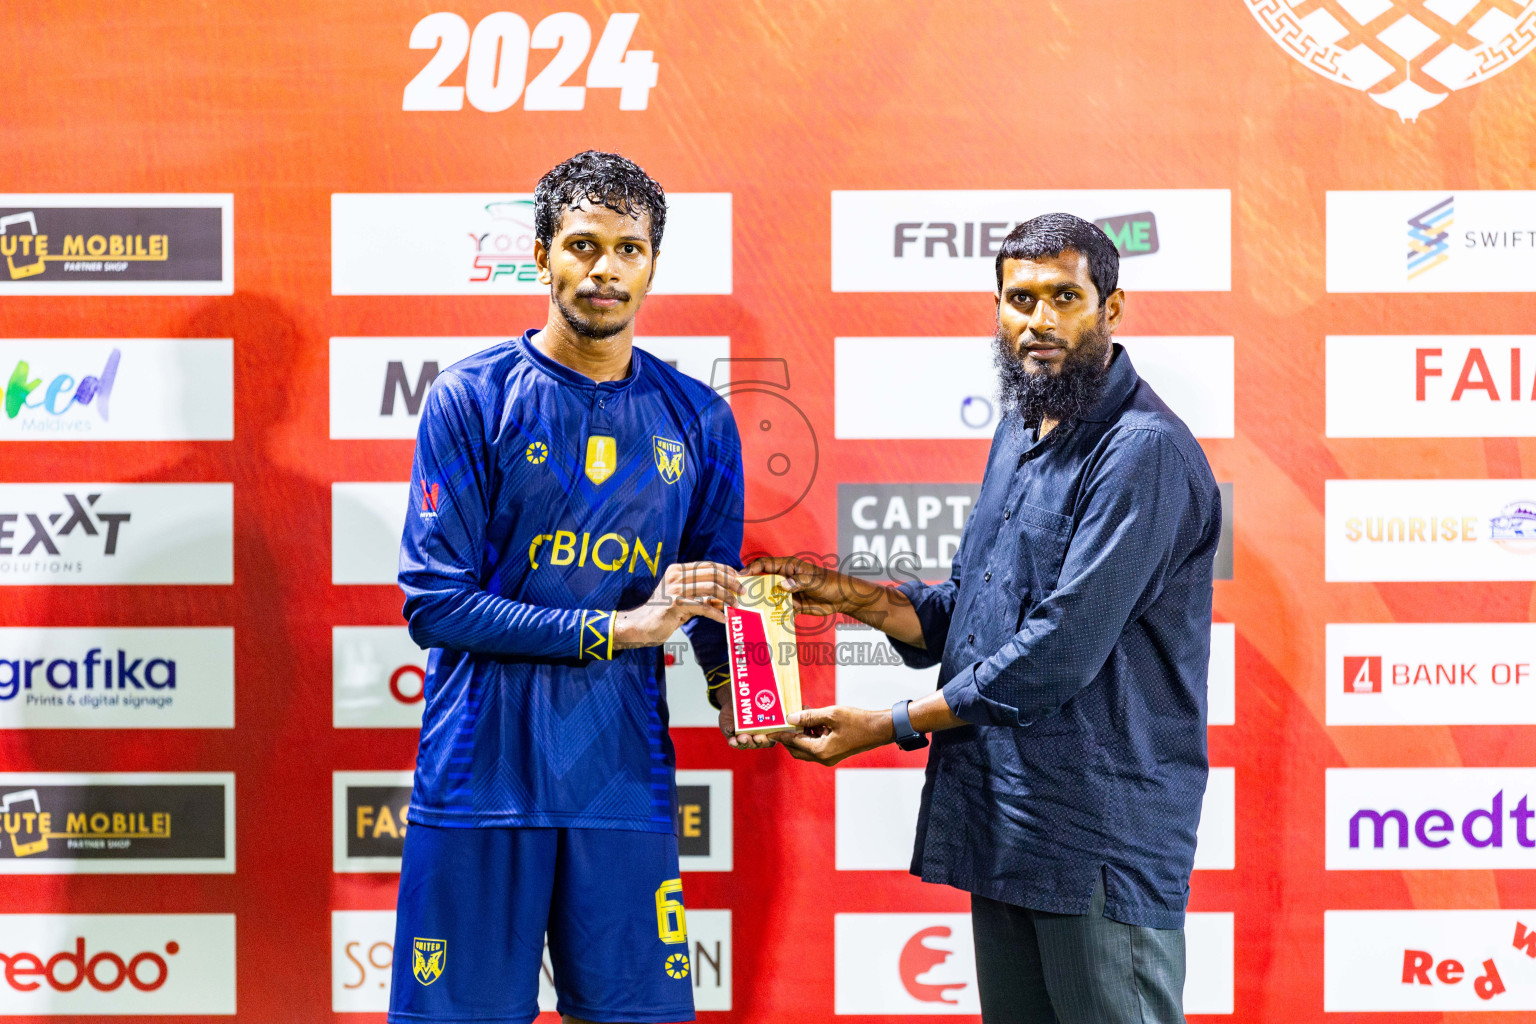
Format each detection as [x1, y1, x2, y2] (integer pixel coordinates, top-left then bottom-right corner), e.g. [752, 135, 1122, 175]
[9, 0, 1536, 1024]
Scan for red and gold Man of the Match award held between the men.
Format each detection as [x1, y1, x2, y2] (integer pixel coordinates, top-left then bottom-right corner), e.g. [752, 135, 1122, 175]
[725, 576, 800, 734]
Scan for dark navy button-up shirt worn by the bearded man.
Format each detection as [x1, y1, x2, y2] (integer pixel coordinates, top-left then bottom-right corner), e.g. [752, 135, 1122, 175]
[895, 345, 1221, 927]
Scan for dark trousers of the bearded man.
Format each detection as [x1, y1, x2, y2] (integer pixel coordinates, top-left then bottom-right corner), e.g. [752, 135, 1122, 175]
[971, 881, 1184, 1024]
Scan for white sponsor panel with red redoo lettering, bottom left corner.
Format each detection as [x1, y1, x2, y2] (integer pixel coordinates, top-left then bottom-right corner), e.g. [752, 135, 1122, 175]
[0, 913, 235, 1016]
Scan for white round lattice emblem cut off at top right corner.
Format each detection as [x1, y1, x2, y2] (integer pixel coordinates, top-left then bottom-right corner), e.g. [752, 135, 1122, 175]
[1243, 0, 1536, 121]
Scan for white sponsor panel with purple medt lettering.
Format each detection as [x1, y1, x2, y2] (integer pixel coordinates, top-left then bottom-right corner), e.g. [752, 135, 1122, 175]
[1324, 768, 1536, 870]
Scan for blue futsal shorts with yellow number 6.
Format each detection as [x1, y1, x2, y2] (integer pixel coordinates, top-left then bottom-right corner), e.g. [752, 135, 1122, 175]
[389, 824, 694, 1024]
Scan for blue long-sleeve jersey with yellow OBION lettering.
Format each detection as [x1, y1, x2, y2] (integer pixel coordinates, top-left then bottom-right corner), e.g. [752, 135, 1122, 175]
[399, 330, 743, 832]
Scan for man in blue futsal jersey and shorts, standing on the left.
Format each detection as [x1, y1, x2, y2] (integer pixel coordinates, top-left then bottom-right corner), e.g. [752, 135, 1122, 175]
[389, 152, 771, 1024]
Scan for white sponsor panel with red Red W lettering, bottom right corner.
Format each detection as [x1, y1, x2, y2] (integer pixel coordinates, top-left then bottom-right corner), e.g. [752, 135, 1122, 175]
[1322, 910, 1536, 1019]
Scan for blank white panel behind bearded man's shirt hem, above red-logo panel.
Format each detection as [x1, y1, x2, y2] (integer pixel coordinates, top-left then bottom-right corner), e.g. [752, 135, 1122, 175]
[834, 768, 1236, 870]
